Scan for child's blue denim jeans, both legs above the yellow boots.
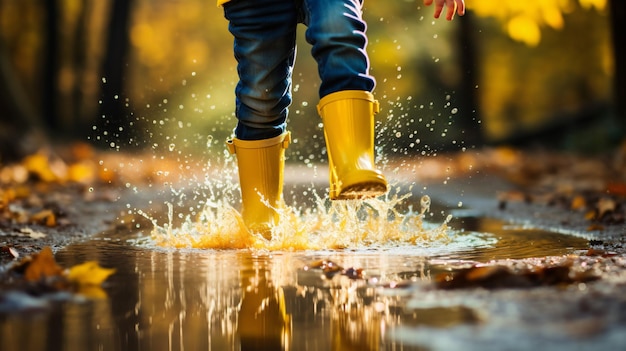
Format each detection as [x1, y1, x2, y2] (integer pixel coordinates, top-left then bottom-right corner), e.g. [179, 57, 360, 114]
[224, 0, 376, 140]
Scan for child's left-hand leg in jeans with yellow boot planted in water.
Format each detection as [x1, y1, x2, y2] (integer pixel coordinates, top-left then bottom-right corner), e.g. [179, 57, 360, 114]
[224, 0, 297, 239]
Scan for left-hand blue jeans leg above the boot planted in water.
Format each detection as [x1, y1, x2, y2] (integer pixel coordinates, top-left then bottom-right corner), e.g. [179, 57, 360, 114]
[224, 0, 297, 140]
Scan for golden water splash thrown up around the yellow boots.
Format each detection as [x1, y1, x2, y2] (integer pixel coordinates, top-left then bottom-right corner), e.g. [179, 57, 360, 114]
[140, 183, 451, 251]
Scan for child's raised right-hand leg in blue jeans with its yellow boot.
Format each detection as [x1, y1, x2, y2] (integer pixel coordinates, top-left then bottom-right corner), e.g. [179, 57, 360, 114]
[304, 0, 387, 200]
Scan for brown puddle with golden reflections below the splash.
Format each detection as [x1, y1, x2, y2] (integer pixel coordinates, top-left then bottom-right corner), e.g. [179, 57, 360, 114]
[0, 199, 587, 350]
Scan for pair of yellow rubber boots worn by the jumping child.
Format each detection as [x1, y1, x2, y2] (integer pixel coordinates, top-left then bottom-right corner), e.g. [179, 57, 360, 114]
[227, 90, 387, 237]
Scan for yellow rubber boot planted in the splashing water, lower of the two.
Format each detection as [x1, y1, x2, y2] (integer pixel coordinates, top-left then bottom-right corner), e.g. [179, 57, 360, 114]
[226, 132, 291, 239]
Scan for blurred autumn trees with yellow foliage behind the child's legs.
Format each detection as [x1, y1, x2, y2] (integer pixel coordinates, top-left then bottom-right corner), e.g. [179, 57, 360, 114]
[0, 0, 623, 161]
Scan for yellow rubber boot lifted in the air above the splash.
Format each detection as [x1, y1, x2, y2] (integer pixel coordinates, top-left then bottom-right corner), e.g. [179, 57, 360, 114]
[317, 90, 387, 200]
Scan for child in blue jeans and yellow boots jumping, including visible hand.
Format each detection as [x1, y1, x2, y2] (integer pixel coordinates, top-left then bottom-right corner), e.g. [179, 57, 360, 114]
[217, 0, 465, 236]
